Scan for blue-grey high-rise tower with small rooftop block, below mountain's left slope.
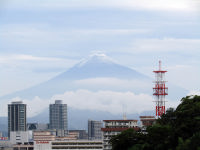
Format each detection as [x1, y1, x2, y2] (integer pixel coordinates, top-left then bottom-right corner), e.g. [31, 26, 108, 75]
[49, 100, 67, 130]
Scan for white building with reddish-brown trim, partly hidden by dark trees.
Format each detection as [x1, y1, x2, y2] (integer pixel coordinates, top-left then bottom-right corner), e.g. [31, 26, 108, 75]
[101, 120, 140, 150]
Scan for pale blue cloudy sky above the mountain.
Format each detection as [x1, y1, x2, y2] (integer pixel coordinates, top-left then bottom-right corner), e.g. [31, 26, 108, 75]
[0, 0, 200, 95]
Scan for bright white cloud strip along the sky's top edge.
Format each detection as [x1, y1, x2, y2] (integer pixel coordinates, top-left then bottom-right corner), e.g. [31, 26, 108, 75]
[4, 0, 197, 11]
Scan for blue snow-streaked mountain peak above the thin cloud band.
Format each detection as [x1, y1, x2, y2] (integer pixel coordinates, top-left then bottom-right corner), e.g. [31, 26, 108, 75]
[53, 55, 148, 80]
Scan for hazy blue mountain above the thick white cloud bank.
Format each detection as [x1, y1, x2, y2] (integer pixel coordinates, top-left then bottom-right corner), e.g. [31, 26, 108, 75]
[0, 54, 151, 99]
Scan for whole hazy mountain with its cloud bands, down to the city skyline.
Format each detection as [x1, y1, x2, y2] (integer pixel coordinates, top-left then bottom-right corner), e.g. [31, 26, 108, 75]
[0, 54, 187, 129]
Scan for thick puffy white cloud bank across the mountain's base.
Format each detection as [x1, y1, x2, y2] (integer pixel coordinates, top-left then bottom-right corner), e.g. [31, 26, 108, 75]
[1, 90, 179, 117]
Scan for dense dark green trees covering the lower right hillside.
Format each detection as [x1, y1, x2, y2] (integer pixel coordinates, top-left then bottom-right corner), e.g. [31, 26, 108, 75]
[110, 96, 200, 150]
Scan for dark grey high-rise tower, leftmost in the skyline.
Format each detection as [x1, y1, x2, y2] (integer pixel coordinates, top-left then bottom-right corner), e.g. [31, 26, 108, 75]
[8, 101, 26, 137]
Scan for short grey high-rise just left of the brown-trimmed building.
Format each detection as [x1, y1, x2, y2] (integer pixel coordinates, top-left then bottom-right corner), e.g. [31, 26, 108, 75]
[88, 120, 103, 140]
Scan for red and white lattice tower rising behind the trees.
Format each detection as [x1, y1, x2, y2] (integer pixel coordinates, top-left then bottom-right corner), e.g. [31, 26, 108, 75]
[153, 61, 168, 117]
